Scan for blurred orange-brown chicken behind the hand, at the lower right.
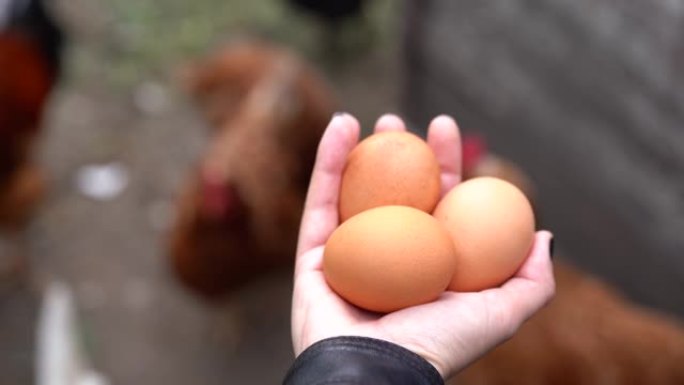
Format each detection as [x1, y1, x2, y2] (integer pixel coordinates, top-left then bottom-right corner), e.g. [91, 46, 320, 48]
[451, 136, 684, 385]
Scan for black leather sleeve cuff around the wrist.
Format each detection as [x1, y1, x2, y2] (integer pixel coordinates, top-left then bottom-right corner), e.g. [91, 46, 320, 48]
[283, 337, 444, 385]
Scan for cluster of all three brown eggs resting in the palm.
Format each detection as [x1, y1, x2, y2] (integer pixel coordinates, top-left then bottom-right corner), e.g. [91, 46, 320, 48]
[323, 131, 535, 313]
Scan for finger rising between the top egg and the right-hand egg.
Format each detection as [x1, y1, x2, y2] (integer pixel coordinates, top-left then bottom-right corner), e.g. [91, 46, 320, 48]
[427, 115, 461, 196]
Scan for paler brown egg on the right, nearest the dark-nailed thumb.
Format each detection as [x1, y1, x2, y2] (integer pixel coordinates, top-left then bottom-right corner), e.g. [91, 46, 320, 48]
[434, 177, 535, 291]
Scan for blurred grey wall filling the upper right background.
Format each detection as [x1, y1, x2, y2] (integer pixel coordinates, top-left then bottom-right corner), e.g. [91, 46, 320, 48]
[404, 0, 684, 316]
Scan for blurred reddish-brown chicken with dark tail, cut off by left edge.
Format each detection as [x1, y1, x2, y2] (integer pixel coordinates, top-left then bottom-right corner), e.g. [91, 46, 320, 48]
[0, 0, 62, 230]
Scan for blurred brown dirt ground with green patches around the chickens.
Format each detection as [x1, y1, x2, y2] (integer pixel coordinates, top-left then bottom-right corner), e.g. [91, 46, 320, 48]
[0, 0, 400, 385]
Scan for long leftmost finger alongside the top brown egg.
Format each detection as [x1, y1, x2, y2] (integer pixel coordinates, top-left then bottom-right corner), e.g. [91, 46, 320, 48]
[297, 114, 360, 266]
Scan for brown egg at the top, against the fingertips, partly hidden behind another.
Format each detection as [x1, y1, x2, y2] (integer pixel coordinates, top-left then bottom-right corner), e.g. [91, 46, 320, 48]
[339, 132, 440, 222]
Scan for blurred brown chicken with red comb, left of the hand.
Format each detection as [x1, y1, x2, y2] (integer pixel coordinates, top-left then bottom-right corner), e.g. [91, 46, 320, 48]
[170, 42, 334, 298]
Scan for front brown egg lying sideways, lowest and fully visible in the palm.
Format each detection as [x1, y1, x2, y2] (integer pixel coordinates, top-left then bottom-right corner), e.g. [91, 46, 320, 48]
[323, 206, 456, 313]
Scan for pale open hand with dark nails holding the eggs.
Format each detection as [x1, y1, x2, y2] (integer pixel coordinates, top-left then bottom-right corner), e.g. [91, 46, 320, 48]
[292, 114, 555, 378]
